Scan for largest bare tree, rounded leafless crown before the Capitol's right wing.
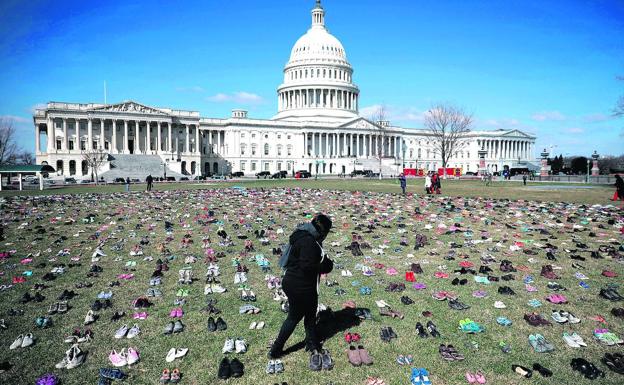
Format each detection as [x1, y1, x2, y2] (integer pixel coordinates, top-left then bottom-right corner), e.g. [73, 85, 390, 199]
[425, 103, 472, 176]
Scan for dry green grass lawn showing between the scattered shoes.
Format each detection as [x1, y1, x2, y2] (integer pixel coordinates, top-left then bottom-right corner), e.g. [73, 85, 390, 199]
[0, 184, 624, 385]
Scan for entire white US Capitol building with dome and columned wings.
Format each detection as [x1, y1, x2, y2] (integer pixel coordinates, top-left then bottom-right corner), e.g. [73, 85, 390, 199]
[33, 0, 535, 180]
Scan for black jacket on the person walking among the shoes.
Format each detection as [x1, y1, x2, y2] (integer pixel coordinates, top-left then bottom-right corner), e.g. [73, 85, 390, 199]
[283, 230, 334, 295]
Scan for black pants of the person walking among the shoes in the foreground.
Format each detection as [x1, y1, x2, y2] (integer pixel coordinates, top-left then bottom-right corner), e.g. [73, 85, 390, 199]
[271, 282, 321, 353]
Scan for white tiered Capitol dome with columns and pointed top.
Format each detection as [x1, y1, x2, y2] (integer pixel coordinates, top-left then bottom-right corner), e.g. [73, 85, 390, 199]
[273, 0, 360, 123]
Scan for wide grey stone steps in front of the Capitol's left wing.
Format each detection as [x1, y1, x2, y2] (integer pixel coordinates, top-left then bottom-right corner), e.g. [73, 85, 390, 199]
[101, 154, 183, 181]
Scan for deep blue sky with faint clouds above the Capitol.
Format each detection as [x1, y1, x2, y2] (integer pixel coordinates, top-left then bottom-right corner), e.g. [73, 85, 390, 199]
[0, 0, 624, 155]
